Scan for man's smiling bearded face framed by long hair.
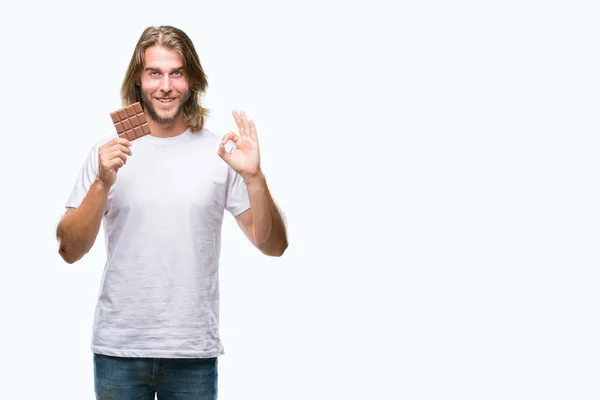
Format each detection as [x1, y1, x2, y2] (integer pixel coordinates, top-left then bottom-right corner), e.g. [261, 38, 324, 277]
[140, 46, 190, 125]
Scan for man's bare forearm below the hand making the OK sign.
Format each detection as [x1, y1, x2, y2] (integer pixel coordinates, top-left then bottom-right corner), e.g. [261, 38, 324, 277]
[244, 172, 288, 256]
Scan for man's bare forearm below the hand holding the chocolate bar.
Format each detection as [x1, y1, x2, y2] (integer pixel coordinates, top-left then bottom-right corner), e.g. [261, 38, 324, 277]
[56, 180, 109, 264]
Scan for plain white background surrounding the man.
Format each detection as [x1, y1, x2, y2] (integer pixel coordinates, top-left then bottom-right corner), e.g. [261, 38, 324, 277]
[0, 0, 600, 400]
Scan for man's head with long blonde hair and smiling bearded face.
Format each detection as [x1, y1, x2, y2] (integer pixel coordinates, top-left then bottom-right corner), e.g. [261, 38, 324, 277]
[121, 26, 208, 132]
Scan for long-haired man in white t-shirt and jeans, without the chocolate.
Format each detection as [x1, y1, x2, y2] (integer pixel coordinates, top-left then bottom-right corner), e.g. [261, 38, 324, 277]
[56, 26, 287, 400]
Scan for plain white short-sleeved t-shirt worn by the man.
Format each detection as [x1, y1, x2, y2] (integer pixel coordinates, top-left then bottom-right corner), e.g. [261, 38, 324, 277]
[66, 129, 250, 358]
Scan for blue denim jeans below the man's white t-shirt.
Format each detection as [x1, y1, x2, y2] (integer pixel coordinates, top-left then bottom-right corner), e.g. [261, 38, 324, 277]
[94, 354, 218, 400]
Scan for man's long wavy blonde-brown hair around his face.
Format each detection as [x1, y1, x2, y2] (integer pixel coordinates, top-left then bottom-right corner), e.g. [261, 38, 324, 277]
[121, 25, 208, 132]
